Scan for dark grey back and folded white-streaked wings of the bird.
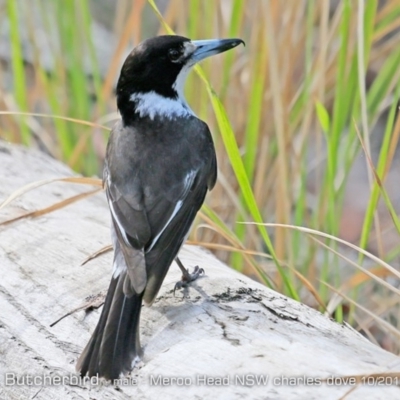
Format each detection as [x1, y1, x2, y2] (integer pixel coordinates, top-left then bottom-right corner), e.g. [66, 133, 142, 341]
[104, 118, 216, 304]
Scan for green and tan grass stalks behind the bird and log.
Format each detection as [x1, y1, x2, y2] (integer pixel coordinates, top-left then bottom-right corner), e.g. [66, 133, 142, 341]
[0, 0, 400, 353]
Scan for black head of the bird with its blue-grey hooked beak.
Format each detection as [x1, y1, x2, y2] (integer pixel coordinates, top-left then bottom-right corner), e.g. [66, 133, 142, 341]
[117, 35, 244, 122]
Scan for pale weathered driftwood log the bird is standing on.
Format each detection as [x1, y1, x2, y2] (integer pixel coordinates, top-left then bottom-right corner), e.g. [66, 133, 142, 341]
[0, 143, 400, 399]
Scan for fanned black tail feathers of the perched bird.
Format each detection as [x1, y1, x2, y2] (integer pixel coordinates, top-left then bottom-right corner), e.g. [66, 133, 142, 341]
[76, 271, 143, 379]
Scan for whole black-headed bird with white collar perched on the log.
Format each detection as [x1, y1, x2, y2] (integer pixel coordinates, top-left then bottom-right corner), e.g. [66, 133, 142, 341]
[77, 36, 244, 379]
